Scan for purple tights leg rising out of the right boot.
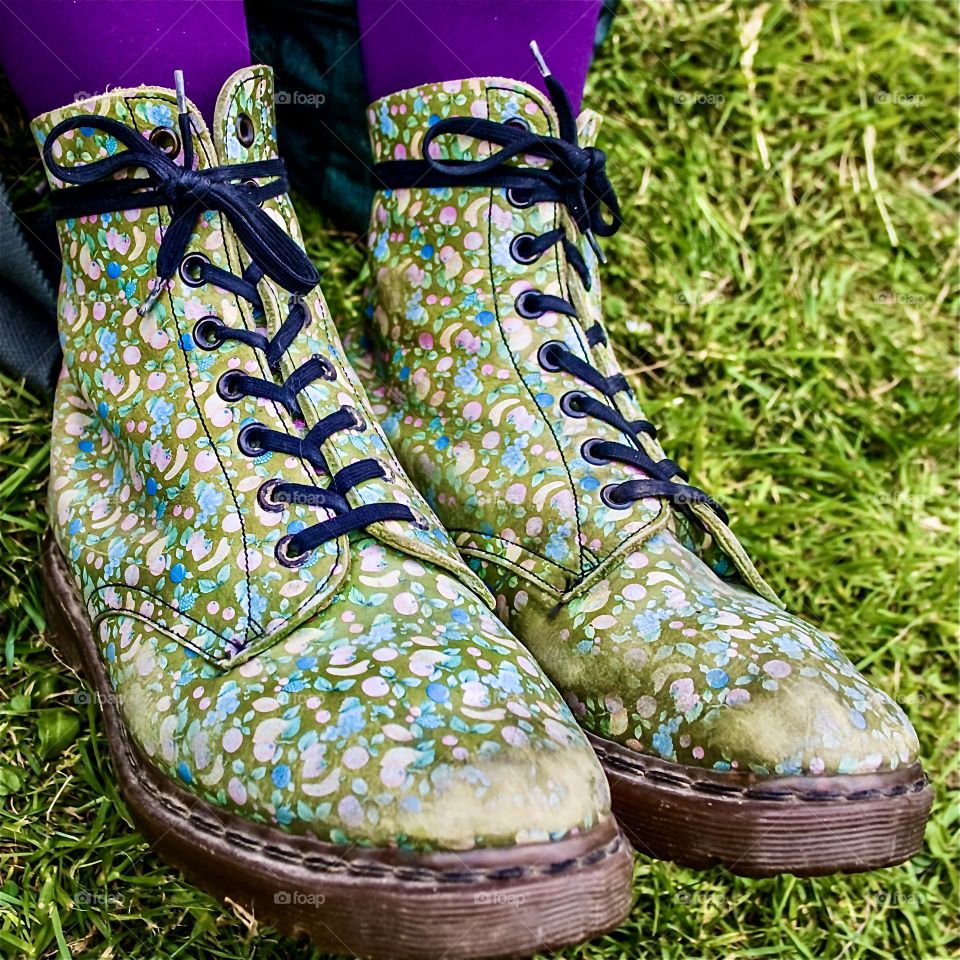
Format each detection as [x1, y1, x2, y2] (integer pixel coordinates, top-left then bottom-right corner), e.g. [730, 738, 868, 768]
[357, 0, 601, 110]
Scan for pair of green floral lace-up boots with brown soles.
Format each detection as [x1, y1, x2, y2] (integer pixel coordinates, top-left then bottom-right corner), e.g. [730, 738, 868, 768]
[34, 67, 930, 958]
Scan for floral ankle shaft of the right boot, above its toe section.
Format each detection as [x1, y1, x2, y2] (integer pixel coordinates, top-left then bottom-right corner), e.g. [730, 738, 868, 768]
[369, 78, 770, 595]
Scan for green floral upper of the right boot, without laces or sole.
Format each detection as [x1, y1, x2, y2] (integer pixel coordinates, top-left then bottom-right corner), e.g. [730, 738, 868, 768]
[359, 79, 917, 774]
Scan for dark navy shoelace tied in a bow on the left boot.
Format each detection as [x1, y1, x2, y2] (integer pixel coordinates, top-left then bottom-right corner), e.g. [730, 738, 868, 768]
[43, 101, 424, 567]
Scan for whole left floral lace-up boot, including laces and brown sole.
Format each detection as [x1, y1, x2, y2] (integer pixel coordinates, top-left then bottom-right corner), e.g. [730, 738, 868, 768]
[34, 67, 632, 958]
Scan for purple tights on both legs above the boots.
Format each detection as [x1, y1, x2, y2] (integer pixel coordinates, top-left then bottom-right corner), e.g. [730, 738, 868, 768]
[0, 0, 600, 120]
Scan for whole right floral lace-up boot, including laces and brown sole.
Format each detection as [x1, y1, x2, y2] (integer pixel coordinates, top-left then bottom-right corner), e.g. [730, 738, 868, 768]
[358, 56, 931, 874]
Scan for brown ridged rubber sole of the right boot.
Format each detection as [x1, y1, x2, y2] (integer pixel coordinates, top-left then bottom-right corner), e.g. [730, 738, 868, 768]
[588, 734, 933, 877]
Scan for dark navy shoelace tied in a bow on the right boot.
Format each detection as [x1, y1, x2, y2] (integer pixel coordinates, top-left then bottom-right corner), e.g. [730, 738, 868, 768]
[375, 50, 728, 523]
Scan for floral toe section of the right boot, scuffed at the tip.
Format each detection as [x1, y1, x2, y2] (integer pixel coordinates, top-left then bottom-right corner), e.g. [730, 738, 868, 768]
[536, 537, 918, 775]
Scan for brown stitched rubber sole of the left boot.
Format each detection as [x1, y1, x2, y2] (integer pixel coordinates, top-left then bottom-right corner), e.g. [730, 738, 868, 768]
[43, 537, 633, 960]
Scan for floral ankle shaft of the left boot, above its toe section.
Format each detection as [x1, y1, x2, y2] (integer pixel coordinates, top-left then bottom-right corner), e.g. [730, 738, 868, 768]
[34, 67, 492, 665]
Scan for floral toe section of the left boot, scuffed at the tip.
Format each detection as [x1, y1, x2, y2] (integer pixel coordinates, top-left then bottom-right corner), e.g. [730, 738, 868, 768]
[110, 560, 609, 850]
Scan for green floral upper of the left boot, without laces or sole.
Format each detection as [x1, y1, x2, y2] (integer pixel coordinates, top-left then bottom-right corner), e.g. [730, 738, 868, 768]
[34, 67, 609, 849]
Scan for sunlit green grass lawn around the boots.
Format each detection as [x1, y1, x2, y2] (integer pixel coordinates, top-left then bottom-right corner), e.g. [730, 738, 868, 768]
[0, 0, 960, 960]
